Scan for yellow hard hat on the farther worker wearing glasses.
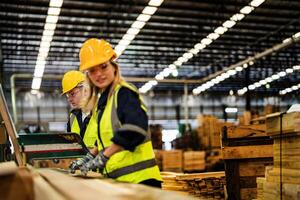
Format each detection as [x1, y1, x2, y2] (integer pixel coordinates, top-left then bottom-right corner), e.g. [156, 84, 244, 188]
[62, 70, 85, 94]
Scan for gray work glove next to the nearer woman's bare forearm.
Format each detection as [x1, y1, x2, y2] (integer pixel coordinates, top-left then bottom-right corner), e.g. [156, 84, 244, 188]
[80, 151, 109, 175]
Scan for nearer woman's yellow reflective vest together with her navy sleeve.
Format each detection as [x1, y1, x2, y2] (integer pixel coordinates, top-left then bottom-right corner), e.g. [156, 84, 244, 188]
[91, 82, 162, 183]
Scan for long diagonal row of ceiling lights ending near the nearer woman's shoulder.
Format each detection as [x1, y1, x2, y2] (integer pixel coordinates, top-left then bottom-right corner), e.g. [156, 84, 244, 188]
[139, 0, 265, 93]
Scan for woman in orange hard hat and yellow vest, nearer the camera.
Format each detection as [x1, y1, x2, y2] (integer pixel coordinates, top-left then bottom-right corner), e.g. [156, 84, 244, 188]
[69, 39, 162, 187]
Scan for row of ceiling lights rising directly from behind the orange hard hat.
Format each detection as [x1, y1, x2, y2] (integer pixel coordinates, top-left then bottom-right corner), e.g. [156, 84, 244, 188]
[115, 0, 164, 56]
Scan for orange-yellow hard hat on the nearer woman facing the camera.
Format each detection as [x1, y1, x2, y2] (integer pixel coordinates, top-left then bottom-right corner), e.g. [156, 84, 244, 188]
[79, 38, 117, 71]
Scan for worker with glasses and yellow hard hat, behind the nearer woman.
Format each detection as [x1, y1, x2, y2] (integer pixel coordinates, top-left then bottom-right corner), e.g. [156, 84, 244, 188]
[62, 70, 96, 149]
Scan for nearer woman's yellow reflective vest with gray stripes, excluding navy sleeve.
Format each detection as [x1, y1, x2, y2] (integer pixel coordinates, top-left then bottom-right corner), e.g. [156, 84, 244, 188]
[97, 82, 162, 183]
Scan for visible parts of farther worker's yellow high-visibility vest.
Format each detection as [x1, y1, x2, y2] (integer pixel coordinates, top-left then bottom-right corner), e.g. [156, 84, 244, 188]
[70, 113, 97, 148]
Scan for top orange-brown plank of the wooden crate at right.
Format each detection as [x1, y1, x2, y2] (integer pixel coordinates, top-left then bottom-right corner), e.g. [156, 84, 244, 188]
[227, 124, 267, 138]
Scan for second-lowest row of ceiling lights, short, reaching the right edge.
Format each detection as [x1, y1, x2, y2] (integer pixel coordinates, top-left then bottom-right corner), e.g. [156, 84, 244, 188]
[237, 65, 300, 95]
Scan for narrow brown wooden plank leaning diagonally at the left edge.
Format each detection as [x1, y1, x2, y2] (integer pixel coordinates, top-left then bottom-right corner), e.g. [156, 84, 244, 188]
[0, 84, 25, 166]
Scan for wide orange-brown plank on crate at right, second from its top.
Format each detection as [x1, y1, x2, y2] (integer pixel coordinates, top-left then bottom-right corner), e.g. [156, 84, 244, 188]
[222, 145, 273, 159]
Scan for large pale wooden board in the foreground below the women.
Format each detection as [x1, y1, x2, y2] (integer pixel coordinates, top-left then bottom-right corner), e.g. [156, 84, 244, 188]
[38, 169, 191, 200]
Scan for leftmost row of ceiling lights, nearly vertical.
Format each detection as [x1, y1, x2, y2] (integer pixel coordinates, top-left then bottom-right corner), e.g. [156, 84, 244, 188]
[31, 0, 63, 93]
